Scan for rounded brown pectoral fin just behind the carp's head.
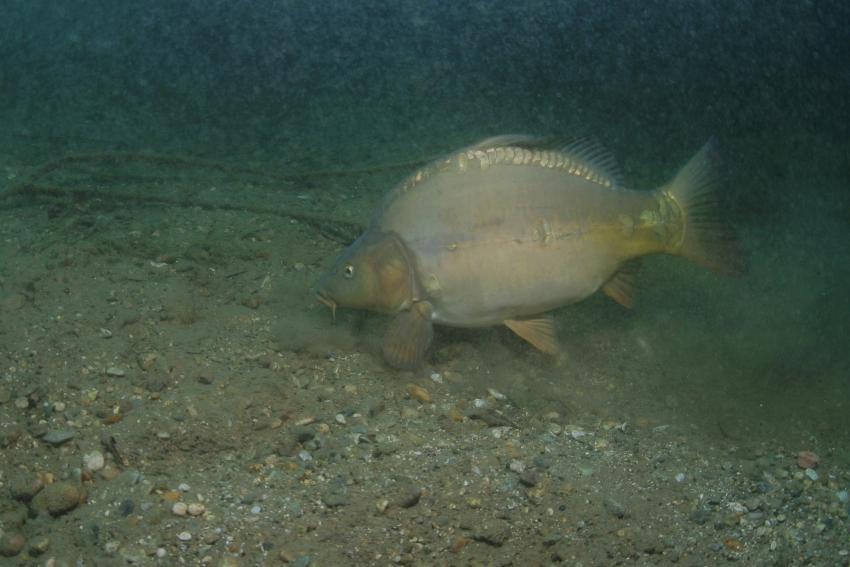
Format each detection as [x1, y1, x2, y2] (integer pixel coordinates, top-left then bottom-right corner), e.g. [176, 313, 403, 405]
[383, 301, 434, 370]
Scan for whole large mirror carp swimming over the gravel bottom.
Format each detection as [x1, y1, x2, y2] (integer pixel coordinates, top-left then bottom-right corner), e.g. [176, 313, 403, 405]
[313, 135, 745, 369]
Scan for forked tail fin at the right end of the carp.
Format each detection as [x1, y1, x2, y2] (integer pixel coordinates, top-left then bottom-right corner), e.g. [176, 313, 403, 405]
[661, 139, 746, 274]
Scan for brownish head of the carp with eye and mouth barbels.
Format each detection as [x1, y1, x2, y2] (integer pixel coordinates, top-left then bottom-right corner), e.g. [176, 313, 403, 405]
[313, 232, 416, 313]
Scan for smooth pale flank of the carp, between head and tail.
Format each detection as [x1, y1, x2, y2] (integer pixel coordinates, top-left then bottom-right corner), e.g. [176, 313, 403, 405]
[383, 167, 647, 327]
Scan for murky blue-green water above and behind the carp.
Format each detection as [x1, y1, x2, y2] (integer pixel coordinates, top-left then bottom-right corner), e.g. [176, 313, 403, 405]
[0, 0, 850, 448]
